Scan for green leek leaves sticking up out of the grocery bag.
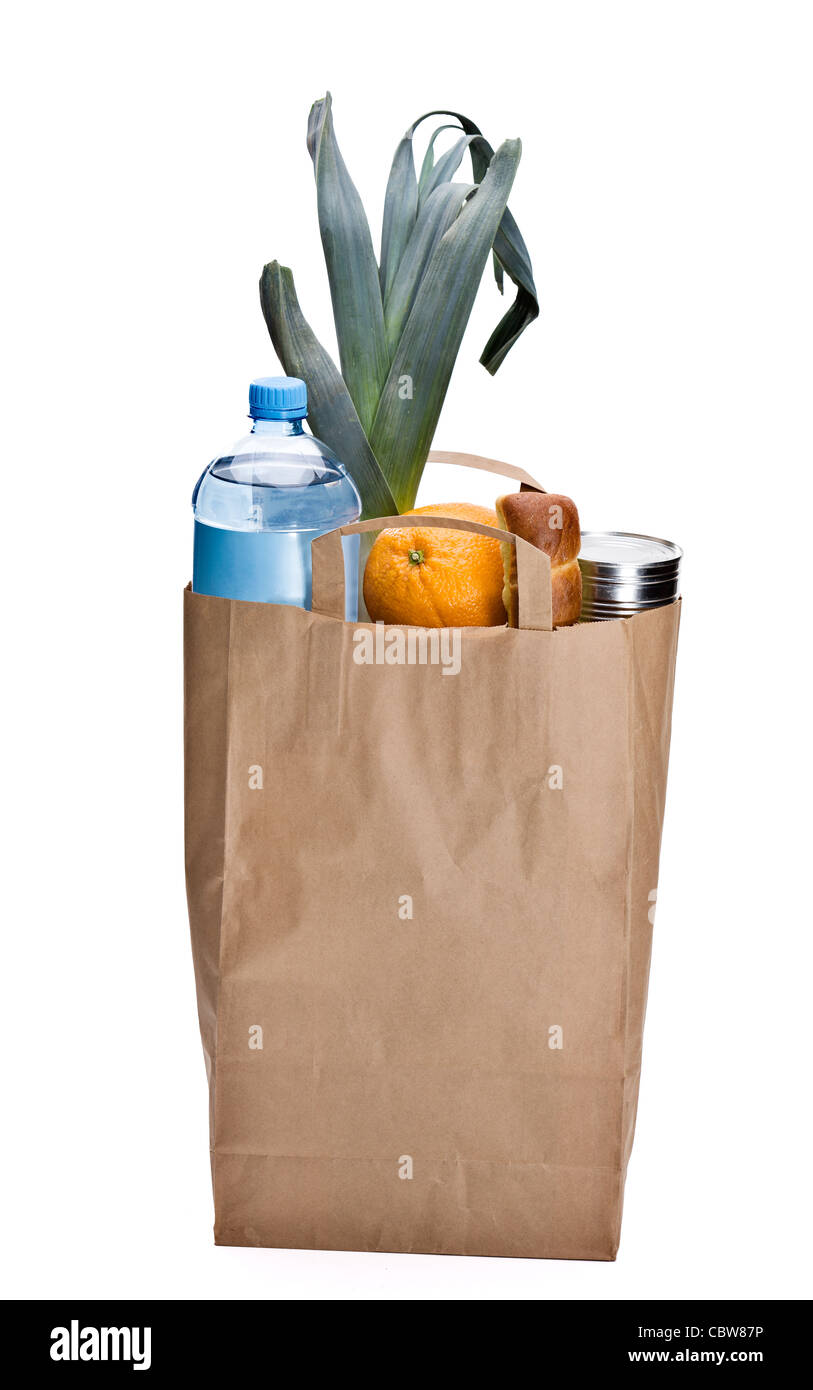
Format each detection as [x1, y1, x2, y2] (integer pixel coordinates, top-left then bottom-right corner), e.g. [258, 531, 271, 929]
[260, 93, 539, 517]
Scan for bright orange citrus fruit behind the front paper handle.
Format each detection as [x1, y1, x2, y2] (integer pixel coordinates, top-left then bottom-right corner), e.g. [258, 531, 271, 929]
[364, 502, 506, 627]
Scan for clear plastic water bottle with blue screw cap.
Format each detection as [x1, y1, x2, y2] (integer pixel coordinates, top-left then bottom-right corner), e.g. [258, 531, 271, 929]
[192, 377, 361, 620]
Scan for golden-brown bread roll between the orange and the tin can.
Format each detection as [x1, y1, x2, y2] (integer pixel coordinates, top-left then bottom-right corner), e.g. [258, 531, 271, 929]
[496, 492, 581, 627]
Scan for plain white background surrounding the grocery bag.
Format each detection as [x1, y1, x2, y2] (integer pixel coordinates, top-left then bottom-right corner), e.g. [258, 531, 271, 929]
[0, 0, 813, 1300]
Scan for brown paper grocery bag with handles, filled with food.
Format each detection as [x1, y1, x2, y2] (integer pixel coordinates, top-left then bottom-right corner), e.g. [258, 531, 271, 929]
[185, 457, 680, 1259]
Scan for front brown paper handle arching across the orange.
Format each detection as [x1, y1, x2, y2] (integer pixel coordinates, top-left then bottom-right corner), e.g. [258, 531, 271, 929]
[310, 517, 553, 632]
